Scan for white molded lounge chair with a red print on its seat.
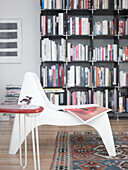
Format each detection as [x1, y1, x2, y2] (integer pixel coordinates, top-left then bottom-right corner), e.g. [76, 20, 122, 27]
[9, 72, 116, 156]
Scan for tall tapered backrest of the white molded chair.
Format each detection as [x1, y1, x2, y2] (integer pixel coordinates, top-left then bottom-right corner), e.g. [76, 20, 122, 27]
[19, 72, 57, 110]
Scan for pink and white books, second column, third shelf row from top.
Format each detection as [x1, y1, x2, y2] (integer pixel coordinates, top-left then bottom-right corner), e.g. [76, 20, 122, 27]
[67, 42, 91, 62]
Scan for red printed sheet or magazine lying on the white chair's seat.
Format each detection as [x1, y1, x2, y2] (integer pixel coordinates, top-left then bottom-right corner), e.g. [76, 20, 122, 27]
[59, 106, 111, 121]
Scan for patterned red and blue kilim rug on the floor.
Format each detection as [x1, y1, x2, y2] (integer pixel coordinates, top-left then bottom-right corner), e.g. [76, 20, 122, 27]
[51, 132, 128, 170]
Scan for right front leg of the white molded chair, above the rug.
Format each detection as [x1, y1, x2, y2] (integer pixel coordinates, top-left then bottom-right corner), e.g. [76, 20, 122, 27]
[87, 113, 116, 156]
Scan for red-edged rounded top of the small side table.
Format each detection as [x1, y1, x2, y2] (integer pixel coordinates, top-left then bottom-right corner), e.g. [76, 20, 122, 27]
[0, 105, 44, 114]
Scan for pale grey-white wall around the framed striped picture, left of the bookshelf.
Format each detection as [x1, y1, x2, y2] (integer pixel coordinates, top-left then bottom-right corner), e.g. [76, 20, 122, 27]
[0, 0, 40, 103]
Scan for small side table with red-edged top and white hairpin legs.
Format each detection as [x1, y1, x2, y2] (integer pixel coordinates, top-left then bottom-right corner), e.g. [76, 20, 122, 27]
[0, 105, 44, 170]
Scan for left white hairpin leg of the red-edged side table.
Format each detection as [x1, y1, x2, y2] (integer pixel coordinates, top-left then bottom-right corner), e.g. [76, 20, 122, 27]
[19, 115, 27, 169]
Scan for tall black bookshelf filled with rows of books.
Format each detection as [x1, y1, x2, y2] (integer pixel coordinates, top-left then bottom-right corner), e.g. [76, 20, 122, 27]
[40, 0, 128, 116]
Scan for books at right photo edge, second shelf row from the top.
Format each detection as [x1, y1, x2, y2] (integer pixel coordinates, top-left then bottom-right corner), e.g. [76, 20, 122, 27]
[119, 18, 128, 35]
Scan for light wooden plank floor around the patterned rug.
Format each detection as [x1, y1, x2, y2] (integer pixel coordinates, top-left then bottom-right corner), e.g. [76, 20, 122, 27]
[0, 118, 128, 170]
